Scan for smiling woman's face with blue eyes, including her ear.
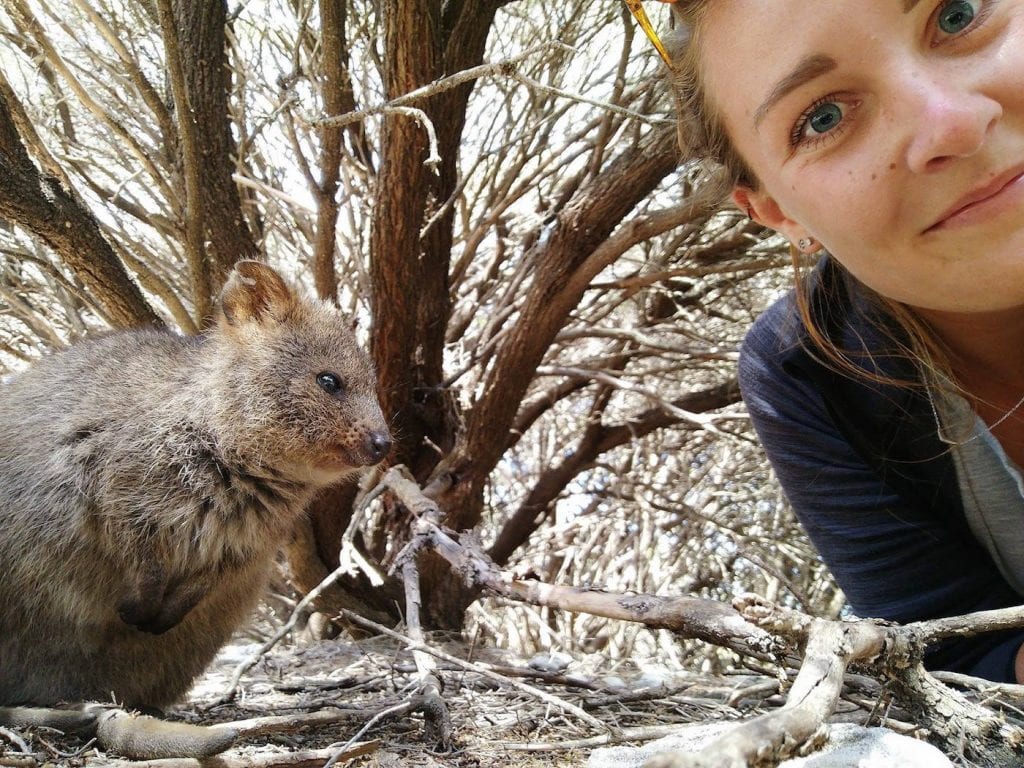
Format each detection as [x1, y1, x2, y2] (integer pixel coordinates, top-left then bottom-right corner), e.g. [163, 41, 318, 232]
[702, 0, 1024, 312]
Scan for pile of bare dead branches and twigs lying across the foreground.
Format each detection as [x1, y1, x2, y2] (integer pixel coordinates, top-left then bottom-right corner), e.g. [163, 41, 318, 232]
[6, 467, 1024, 768]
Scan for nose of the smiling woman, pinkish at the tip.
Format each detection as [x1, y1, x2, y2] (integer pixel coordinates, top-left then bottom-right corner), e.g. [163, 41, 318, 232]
[898, 73, 1002, 173]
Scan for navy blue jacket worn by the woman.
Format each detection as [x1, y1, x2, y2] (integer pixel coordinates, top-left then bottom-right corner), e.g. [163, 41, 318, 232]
[739, 258, 1024, 682]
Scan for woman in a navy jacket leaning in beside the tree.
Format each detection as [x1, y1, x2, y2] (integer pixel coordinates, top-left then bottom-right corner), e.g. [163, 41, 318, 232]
[659, 0, 1024, 681]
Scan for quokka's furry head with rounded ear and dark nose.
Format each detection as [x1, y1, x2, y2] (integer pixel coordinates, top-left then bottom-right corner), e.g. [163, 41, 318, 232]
[214, 261, 391, 482]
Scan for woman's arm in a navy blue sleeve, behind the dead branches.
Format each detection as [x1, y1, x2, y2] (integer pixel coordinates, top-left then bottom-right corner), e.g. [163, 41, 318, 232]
[739, 311, 1024, 681]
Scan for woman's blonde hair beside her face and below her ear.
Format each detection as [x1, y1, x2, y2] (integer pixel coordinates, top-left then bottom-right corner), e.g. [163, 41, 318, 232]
[666, 0, 952, 386]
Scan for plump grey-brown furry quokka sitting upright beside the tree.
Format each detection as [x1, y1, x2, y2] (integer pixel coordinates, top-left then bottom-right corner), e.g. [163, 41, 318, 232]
[0, 261, 391, 707]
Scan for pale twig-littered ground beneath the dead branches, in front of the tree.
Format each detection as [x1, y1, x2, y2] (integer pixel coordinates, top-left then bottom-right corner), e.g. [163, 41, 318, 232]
[0, 637, 774, 768]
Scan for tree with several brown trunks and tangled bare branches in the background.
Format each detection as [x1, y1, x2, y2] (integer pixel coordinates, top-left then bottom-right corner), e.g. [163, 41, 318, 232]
[0, 0, 815, 651]
